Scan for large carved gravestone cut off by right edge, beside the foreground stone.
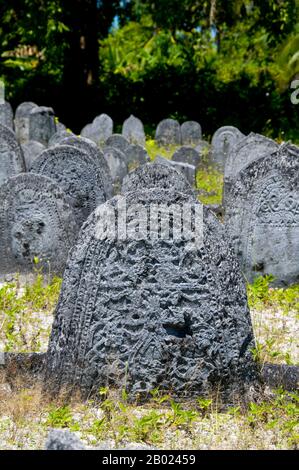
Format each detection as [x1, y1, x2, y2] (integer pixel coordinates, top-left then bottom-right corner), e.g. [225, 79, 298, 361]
[225, 145, 299, 284]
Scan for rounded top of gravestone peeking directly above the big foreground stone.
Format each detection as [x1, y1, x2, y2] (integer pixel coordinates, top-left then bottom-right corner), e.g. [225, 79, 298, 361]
[122, 163, 192, 194]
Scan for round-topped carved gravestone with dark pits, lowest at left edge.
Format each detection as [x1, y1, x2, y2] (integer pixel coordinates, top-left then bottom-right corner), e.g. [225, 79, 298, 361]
[0, 173, 78, 274]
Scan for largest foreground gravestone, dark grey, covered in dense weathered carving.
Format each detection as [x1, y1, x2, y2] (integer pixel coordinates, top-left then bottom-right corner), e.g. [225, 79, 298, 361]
[45, 187, 256, 397]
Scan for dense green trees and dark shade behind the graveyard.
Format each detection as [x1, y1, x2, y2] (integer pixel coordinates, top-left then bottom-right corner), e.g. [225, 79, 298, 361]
[0, 0, 299, 139]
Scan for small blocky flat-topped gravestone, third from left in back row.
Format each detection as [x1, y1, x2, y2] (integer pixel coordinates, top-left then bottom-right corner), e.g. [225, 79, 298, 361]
[29, 106, 56, 145]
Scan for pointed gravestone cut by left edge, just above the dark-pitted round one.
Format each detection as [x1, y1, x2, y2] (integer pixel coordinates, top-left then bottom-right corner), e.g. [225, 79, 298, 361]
[0, 124, 25, 185]
